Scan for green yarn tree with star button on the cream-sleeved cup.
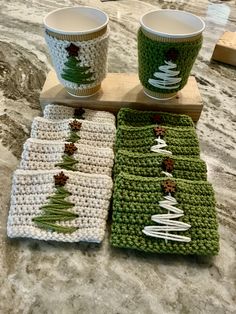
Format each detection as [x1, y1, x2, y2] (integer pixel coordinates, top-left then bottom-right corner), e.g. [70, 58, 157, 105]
[61, 43, 94, 85]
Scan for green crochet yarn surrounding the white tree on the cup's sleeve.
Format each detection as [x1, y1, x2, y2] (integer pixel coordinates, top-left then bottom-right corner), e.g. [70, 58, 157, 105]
[138, 28, 202, 94]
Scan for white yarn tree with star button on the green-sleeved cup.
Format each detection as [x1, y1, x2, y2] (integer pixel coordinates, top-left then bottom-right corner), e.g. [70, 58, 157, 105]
[148, 48, 182, 89]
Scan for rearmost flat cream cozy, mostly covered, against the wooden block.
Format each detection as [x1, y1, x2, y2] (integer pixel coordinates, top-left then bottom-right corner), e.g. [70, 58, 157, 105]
[43, 104, 116, 125]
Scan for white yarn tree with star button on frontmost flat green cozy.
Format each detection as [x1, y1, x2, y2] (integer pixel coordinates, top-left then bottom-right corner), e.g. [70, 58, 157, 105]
[142, 179, 191, 243]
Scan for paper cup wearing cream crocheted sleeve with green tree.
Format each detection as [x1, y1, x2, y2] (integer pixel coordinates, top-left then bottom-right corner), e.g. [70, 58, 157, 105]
[44, 6, 109, 97]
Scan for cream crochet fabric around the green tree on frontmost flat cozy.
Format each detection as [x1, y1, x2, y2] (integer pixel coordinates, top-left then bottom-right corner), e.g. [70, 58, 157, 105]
[7, 170, 112, 242]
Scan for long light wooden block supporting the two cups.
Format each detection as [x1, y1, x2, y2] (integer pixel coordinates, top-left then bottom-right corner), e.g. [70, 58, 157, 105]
[40, 71, 203, 121]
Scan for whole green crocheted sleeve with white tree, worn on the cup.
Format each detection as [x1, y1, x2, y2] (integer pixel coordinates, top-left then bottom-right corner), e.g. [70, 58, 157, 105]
[138, 28, 202, 94]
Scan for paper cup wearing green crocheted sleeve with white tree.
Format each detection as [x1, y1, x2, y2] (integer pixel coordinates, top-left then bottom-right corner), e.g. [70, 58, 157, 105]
[138, 10, 205, 99]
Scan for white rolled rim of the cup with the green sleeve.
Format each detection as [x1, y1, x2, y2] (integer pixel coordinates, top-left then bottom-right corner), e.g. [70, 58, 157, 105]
[140, 9, 206, 38]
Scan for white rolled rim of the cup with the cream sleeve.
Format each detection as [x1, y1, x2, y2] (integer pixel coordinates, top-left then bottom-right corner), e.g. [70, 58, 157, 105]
[43, 5, 109, 35]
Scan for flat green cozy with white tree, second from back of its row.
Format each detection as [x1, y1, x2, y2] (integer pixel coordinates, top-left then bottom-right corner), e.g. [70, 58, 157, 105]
[116, 125, 199, 157]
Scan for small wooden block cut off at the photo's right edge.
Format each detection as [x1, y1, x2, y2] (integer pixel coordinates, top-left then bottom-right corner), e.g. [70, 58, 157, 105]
[212, 32, 236, 66]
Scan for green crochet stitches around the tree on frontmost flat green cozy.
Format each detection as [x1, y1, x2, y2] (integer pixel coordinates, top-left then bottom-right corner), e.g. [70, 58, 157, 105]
[111, 173, 219, 255]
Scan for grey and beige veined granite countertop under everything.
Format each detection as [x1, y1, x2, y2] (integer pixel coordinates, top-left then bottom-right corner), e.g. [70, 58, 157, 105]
[0, 0, 236, 314]
